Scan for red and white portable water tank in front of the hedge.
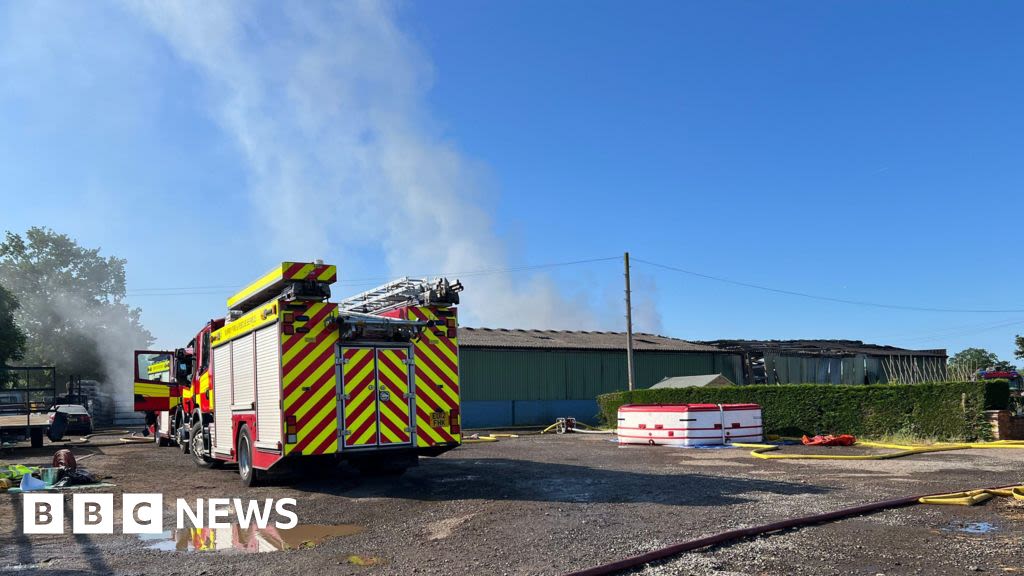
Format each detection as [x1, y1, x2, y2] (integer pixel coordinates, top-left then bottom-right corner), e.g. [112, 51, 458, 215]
[616, 404, 764, 446]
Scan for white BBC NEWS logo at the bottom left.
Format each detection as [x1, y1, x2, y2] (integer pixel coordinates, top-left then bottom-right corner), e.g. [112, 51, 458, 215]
[22, 493, 299, 534]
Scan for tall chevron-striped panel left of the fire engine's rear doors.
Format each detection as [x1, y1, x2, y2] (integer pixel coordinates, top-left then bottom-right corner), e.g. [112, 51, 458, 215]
[281, 301, 338, 454]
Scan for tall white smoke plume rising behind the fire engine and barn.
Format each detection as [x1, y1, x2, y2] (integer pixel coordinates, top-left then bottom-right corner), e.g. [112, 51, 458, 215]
[125, 1, 660, 329]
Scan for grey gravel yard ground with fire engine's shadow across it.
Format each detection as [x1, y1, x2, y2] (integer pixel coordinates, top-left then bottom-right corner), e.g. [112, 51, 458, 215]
[0, 435, 1024, 576]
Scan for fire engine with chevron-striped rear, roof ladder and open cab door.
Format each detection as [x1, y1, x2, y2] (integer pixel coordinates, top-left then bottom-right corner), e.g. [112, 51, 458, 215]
[134, 260, 462, 486]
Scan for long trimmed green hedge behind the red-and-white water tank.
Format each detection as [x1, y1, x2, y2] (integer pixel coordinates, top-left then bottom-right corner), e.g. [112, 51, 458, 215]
[597, 380, 1010, 441]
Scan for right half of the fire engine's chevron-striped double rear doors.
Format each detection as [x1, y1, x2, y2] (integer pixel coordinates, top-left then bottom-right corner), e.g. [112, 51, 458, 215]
[377, 348, 413, 445]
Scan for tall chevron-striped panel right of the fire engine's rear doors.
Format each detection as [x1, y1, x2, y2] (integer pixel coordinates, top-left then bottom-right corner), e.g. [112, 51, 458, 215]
[409, 306, 461, 446]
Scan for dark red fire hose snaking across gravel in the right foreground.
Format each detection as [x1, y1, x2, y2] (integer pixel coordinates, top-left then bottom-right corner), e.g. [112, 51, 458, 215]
[566, 486, 1006, 576]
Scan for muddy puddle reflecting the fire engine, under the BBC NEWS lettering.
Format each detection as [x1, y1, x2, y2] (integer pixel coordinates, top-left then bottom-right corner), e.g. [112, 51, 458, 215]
[138, 524, 364, 553]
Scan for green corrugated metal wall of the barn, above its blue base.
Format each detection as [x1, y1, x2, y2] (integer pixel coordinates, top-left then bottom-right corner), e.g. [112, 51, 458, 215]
[459, 346, 742, 401]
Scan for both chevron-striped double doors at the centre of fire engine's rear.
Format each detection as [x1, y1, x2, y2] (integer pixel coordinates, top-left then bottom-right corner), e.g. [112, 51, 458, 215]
[339, 346, 413, 448]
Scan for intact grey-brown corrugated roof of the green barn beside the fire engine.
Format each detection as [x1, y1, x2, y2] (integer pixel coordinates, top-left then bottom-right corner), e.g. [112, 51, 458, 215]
[459, 327, 725, 353]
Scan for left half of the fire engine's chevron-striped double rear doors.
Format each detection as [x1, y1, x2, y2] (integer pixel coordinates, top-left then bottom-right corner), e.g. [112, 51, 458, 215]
[341, 348, 377, 447]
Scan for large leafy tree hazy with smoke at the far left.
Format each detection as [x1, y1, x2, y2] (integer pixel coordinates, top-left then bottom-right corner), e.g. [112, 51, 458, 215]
[0, 228, 153, 387]
